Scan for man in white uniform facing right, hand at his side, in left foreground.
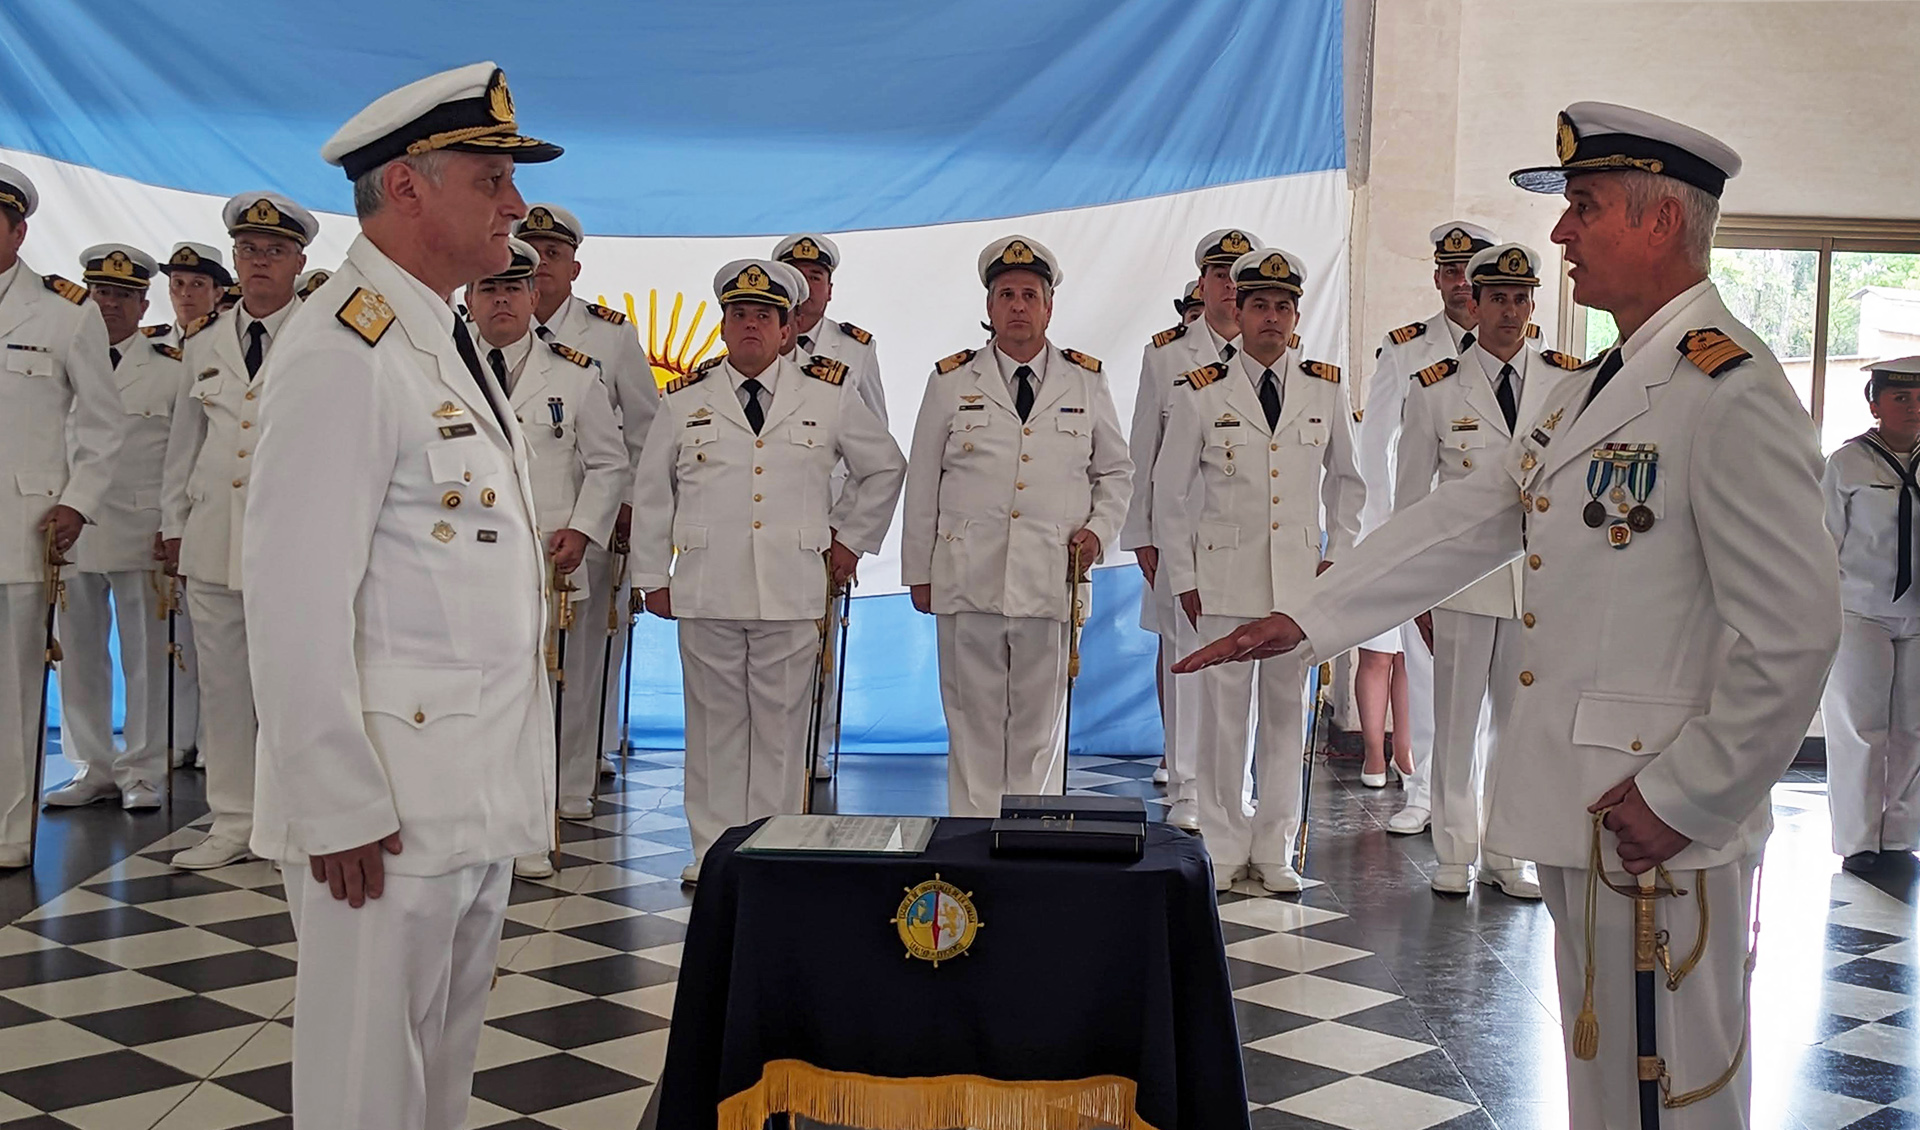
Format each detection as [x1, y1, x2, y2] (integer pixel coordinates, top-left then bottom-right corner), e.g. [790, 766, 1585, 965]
[242, 63, 559, 1130]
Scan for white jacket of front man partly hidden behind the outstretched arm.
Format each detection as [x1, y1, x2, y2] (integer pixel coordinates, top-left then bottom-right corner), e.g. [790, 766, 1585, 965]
[1394, 343, 1592, 620]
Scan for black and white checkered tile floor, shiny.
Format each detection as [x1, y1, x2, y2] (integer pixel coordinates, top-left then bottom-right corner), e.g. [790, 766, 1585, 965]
[0, 754, 1920, 1130]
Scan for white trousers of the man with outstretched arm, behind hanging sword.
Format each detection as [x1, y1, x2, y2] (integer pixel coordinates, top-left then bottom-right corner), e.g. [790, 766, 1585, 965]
[1540, 856, 1759, 1130]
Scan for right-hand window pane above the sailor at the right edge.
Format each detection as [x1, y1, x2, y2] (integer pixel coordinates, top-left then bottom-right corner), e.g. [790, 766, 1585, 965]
[1820, 251, 1920, 451]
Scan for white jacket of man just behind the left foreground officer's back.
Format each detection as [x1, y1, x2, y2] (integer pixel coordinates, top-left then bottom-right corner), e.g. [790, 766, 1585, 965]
[159, 308, 278, 589]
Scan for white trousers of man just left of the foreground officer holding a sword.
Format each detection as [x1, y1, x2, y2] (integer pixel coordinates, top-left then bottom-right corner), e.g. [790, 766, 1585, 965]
[1415, 608, 1515, 871]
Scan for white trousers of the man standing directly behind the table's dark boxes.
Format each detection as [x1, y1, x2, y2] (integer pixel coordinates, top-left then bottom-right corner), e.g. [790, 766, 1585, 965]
[935, 612, 1068, 817]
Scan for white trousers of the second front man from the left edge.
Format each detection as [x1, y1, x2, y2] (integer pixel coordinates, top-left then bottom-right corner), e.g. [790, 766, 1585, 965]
[60, 570, 167, 789]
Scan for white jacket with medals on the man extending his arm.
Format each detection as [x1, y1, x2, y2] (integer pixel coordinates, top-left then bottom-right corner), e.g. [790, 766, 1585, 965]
[1283, 282, 1839, 871]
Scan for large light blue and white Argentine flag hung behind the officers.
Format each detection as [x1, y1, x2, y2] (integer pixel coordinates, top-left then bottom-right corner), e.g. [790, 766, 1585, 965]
[0, 0, 1352, 754]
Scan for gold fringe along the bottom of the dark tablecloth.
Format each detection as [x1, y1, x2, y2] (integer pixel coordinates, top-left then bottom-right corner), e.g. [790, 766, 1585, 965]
[720, 1059, 1154, 1130]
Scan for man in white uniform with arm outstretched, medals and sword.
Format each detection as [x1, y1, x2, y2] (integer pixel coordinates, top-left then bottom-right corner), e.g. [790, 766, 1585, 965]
[1181, 102, 1841, 1130]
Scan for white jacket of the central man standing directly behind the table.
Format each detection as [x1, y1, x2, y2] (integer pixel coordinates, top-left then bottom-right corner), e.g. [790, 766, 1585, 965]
[900, 341, 1133, 622]
